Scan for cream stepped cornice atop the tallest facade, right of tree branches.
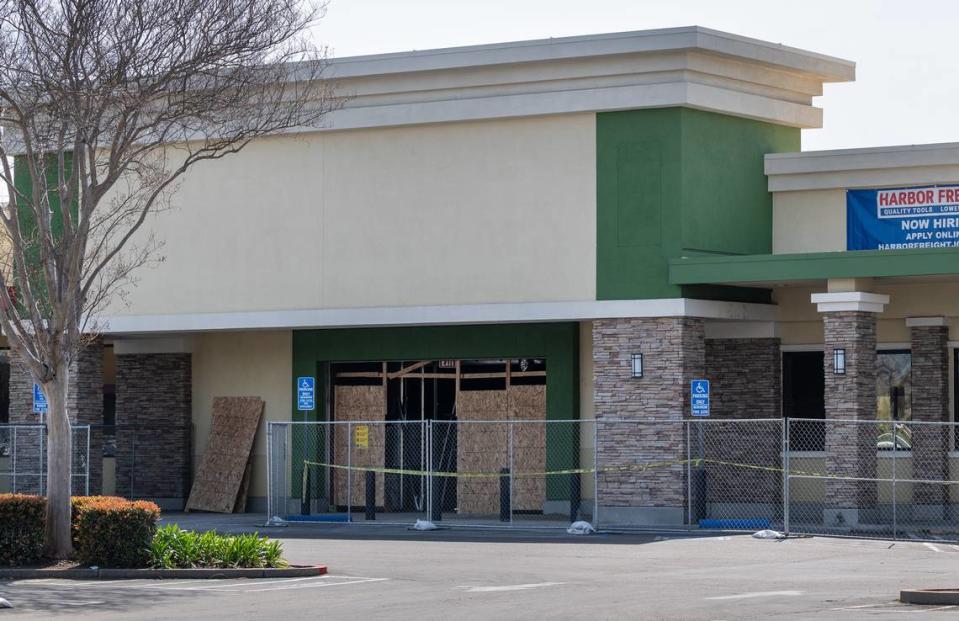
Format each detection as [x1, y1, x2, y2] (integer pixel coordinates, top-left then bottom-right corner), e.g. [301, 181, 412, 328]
[318, 26, 855, 130]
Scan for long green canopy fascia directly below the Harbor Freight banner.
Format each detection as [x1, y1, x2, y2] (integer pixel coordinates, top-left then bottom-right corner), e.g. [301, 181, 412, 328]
[669, 248, 959, 285]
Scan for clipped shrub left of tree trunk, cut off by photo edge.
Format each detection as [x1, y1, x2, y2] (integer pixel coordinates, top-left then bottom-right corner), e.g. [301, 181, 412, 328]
[0, 494, 47, 565]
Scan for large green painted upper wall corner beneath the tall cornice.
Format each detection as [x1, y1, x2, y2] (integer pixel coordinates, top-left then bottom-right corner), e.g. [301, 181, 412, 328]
[596, 108, 800, 301]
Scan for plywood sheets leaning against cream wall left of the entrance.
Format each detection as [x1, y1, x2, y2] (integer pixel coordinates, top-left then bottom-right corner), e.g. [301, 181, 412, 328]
[186, 397, 264, 513]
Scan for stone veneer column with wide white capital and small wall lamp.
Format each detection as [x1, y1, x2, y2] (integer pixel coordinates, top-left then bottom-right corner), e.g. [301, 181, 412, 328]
[812, 291, 889, 527]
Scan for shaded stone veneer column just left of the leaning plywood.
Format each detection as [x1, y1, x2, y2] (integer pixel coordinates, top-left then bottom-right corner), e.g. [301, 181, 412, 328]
[115, 352, 192, 510]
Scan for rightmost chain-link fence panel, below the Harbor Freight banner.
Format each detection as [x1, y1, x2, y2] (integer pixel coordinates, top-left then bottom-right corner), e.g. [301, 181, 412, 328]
[786, 419, 959, 540]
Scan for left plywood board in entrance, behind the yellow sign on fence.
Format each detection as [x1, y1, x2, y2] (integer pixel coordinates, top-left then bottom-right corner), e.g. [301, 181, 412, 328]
[333, 385, 386, 507]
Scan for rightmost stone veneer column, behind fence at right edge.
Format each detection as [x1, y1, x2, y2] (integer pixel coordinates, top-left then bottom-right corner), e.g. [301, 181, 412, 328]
[906, 317, 950, 521]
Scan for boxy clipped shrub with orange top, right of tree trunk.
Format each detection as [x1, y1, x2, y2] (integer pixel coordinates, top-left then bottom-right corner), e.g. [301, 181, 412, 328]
[73, 496, 160, 567]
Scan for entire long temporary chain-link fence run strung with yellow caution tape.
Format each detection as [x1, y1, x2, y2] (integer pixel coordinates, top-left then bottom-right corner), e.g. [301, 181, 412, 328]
[267, 419, 959, 540]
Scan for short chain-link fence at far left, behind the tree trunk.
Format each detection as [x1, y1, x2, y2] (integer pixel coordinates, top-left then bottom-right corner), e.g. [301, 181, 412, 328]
[0, 424, 91, 496]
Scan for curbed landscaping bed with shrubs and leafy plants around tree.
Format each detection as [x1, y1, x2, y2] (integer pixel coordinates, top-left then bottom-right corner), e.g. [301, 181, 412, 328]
[0, 494, 312, 579]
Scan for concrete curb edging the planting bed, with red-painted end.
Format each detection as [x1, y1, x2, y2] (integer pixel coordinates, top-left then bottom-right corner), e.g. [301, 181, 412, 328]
[0, 565, 326, 580]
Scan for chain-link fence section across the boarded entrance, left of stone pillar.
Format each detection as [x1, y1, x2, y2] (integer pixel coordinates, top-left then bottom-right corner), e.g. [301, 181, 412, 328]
[267, 420, 594, 527]
